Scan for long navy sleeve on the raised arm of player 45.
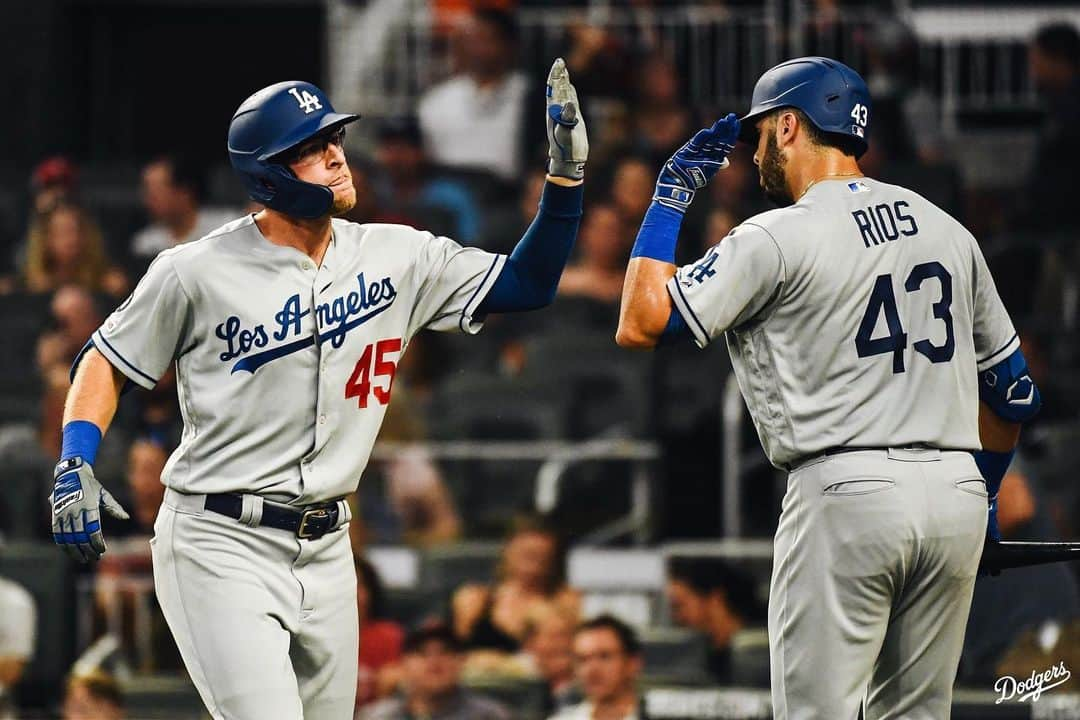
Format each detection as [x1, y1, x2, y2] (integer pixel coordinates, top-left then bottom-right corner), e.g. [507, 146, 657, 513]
[476, 182, 584, 316]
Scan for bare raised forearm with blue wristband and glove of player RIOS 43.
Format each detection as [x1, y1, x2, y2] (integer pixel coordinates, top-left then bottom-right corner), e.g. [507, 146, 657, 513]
[616, 113, 739, 348]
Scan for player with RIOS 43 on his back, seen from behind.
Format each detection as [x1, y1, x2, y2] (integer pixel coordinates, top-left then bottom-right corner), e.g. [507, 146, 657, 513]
[617, 57, 1039, 720]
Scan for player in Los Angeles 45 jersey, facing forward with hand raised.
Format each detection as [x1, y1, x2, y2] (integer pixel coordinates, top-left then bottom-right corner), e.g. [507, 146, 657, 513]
[52, 59, 588, 720]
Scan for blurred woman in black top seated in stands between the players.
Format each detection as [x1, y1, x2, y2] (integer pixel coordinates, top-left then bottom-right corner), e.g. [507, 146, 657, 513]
[453, 517, 581, 654]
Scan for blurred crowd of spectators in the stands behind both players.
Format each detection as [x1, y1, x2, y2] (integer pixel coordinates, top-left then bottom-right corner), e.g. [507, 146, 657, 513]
[0, 2, 1080, 720]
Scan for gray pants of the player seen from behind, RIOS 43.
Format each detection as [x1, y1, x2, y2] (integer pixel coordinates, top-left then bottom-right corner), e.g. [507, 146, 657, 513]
[769, 449, 987, 720]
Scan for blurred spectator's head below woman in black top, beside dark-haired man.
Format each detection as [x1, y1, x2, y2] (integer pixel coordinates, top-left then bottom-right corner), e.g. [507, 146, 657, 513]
[524, 610, 580, 712]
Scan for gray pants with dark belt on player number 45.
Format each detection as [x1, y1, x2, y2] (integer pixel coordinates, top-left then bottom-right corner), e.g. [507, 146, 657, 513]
[151, 489, 360, 720]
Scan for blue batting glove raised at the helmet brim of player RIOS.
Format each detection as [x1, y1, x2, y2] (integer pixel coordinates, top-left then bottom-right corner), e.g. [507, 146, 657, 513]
[652, 112, 739, 213]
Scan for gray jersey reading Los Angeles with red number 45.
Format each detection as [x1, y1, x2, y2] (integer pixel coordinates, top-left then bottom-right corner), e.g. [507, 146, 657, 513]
[93, 216, 505, 504]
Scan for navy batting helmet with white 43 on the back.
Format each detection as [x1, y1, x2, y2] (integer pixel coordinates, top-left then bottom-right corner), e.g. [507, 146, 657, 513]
[740, 57, 870, 158]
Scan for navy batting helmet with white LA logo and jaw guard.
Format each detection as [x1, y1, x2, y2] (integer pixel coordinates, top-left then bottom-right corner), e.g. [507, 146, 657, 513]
[229, 80, 360, 218]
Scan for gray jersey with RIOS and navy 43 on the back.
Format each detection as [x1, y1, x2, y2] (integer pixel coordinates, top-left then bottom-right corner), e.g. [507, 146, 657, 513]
[667, 178, 1020, 466]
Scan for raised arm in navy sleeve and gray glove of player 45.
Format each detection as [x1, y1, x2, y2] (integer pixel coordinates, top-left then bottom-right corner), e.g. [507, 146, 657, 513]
[476, 58, 589, 316]
